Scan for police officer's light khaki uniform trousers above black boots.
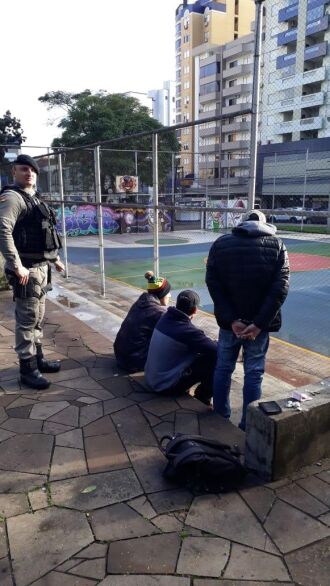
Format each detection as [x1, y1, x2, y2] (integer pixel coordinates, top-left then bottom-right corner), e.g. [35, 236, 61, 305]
[15, 265, 48, 359]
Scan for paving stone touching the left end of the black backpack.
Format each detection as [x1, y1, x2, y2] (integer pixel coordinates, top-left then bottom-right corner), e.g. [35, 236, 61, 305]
[126, 444, 172, 493]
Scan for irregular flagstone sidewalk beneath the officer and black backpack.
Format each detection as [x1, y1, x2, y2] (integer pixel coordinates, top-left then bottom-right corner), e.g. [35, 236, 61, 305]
[0, 282, 330, 586]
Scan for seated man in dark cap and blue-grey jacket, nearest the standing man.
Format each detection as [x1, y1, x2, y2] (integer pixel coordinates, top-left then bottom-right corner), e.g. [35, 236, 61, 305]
[145, 290, 217, 405]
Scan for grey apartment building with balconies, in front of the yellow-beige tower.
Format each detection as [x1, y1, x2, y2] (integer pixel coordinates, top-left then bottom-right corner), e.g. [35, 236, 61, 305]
[194, 33, 254, 195]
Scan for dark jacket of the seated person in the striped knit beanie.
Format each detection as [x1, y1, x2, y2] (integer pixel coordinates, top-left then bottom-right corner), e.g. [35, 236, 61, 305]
[114, 293, 166, 372]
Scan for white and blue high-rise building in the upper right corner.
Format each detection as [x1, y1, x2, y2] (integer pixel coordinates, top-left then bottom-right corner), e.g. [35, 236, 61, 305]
[261, 0, 330, 144]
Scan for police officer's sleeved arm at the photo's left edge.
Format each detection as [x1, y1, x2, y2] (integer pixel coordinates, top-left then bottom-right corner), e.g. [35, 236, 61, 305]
[0, 191, 26, 271]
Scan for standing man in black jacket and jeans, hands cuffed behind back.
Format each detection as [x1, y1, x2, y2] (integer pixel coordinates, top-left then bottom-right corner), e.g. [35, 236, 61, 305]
[206, 210, 290, 430]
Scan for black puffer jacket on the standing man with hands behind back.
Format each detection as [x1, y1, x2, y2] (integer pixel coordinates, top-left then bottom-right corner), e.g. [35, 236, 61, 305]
[206, 221, 290, 332]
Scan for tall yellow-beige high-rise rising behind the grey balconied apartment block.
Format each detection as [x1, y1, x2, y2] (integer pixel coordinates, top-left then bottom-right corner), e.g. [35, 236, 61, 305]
[175, 0, 255, 175]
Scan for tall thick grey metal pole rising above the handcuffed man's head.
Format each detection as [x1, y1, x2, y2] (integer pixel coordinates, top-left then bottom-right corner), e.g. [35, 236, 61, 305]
[248, 0, 265, 210]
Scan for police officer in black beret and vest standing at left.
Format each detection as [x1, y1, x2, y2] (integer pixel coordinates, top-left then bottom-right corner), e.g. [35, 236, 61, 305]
[0, 155, 64, 389]
